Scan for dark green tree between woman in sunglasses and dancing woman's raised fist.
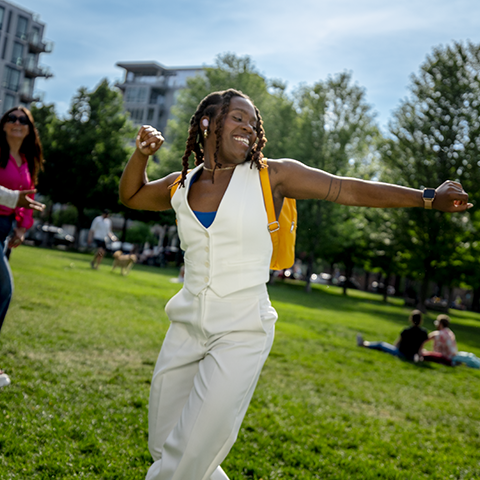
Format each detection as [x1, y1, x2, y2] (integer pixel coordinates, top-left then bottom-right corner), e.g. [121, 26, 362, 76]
[32, 80, 134, 244]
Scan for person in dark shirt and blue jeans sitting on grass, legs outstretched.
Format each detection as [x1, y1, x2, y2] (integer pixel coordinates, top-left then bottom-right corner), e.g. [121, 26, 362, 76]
[357, 310, 428, 361]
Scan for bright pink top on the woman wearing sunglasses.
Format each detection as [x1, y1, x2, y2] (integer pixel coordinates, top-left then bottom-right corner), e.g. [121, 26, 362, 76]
[0, 155, 35, 229]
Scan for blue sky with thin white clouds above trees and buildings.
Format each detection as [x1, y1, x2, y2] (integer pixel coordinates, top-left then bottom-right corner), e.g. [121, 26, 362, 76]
[15, 0, 480, 131]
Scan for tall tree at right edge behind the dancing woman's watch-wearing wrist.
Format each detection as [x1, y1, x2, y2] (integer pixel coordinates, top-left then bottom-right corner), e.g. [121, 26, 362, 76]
[383, 42, 480, 300]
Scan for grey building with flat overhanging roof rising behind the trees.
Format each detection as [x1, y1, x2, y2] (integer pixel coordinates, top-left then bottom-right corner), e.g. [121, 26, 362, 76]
[116, 62, 204, 132]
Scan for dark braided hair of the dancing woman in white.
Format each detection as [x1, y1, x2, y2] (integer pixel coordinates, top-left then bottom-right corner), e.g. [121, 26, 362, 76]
[178, 88, 267, 187]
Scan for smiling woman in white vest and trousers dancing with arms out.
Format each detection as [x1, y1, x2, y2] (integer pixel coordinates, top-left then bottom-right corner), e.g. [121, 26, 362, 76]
[119, 89, 471, 480]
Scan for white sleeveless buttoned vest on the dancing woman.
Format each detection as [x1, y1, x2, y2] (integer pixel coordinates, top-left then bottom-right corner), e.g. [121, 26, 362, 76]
[172, 162, 272, 297]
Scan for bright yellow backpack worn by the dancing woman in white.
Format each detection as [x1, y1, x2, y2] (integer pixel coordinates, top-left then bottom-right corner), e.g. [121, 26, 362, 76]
[170, 159, 297, 270]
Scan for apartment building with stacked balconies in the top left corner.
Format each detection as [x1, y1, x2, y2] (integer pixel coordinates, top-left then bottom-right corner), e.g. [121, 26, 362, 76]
[0, 0, 53, 114]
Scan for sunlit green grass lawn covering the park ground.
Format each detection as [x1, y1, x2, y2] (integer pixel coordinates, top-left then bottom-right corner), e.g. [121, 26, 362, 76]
[0, 247, 480, 480]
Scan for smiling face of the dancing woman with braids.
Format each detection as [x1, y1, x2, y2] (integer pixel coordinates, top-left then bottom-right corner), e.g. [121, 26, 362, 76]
[212, 97, 258, 166]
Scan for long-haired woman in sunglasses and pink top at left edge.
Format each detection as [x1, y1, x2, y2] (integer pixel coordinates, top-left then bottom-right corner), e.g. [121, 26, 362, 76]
[0, 107, 43, 387]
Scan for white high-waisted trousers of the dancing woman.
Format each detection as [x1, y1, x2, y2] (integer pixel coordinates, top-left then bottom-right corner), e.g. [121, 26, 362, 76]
[147, 285, 277, 480]
